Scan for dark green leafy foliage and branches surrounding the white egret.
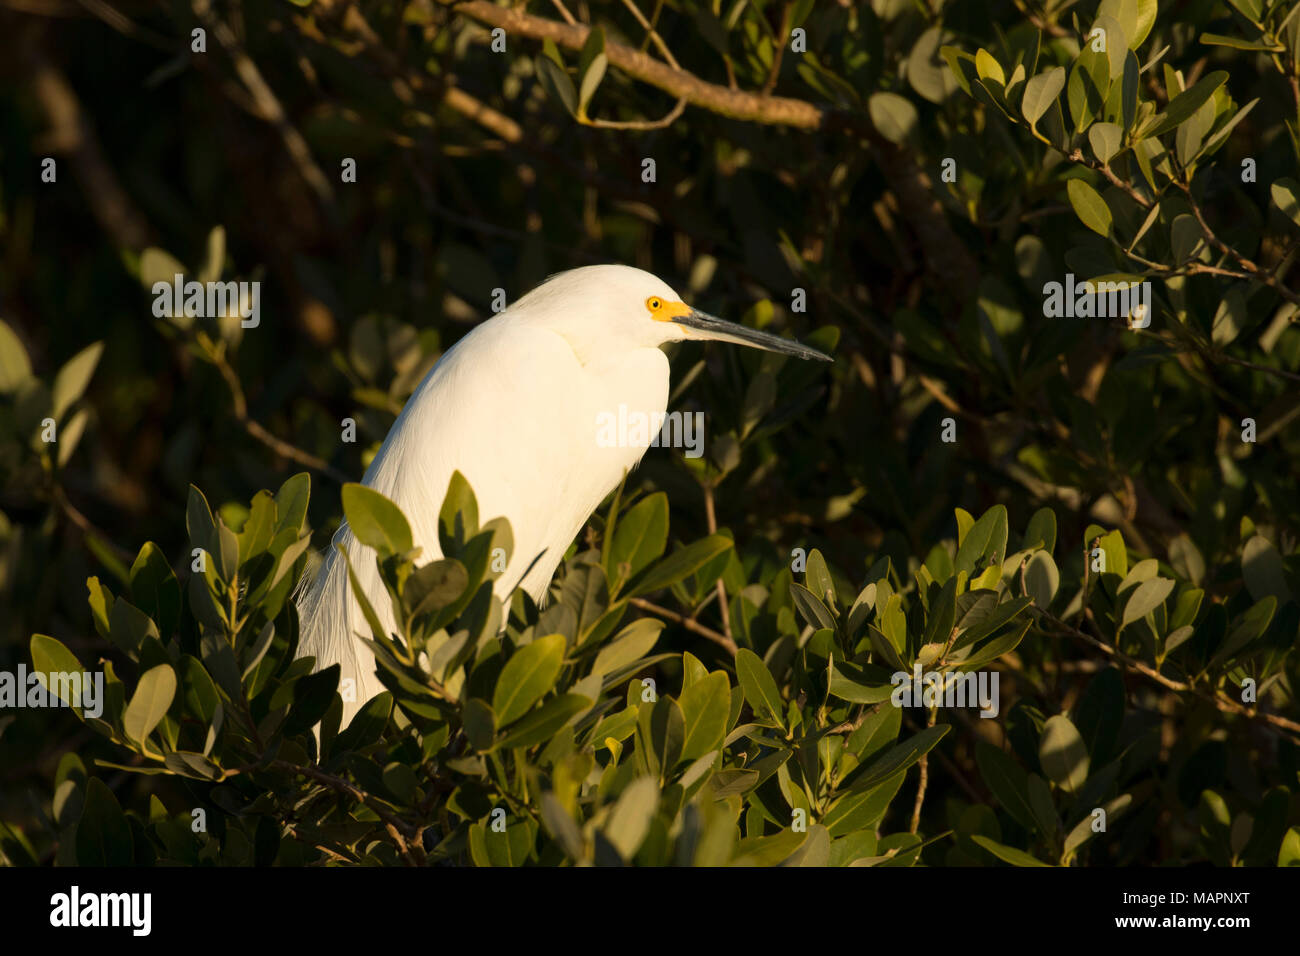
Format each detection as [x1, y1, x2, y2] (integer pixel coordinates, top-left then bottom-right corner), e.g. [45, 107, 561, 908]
[0, 0, 1300, 866]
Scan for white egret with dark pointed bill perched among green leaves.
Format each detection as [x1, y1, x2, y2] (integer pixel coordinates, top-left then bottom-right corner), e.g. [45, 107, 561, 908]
[298, 265, 831, 726]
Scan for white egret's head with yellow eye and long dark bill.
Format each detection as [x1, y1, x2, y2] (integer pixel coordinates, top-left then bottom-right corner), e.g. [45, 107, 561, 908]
[515, 265, 831, 362]
